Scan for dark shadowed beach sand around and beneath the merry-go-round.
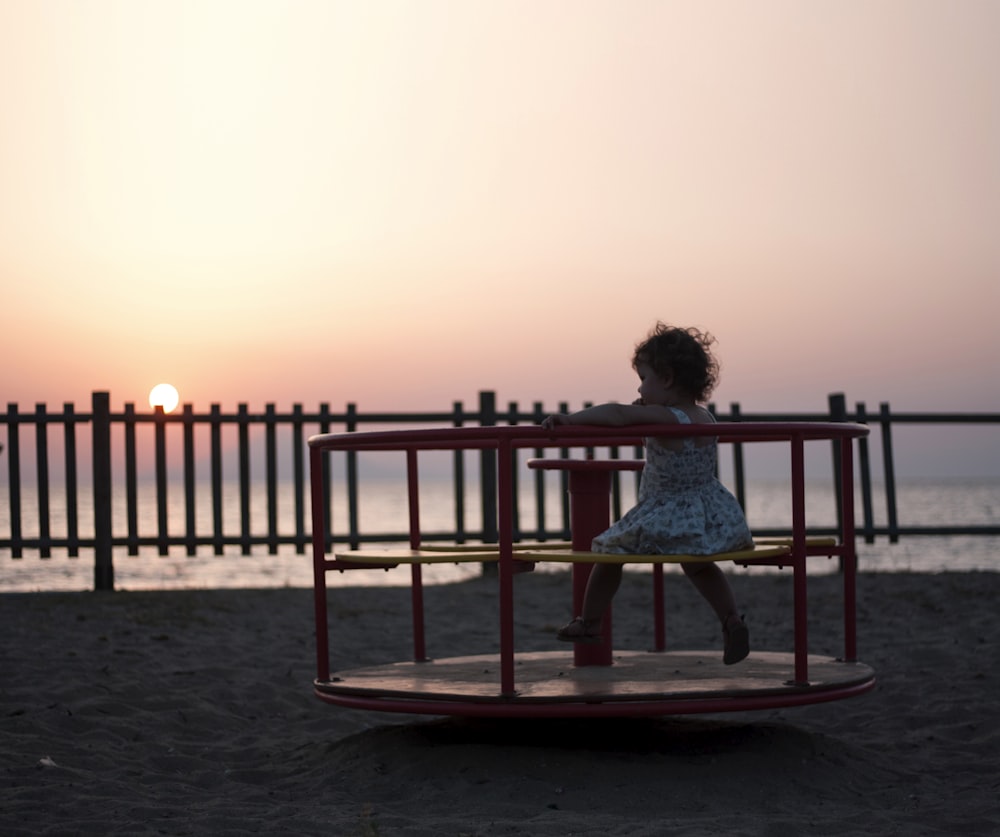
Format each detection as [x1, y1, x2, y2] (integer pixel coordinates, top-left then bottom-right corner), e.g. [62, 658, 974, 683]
[0, 573, 1000, 835]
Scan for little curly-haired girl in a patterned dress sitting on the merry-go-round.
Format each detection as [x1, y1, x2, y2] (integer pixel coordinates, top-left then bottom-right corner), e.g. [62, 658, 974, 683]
[542, 323, 752, 665]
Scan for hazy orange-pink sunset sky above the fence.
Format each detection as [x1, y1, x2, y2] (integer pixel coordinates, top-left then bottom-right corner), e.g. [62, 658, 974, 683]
[0, 0, 1000, 422]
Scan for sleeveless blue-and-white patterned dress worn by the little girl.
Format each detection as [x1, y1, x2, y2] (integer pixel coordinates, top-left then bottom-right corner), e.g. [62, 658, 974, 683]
[592, 407, 752, 555]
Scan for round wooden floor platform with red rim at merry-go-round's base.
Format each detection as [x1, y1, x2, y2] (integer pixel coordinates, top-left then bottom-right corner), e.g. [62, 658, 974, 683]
[314, 651, 875, 717]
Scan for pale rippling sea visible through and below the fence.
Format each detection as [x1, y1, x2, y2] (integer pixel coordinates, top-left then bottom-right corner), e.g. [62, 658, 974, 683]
[0, 478, 1000, 592]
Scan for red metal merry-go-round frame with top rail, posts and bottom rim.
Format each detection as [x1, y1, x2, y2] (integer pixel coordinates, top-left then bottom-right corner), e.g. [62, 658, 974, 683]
[309, 422, 874, 717]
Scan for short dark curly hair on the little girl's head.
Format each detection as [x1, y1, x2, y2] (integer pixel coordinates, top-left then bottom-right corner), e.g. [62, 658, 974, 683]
[632, 322, 719, 402]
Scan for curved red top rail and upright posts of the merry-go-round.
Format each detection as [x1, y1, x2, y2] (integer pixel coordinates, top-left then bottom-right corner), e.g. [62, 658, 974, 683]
[308, 422, 868, 711]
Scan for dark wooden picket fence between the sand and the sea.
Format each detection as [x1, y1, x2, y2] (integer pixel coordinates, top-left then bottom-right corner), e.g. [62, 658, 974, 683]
[0, 391, 1000, 590]
